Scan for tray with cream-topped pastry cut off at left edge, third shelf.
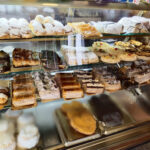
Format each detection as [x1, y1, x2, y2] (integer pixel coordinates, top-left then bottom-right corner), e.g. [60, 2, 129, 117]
[0, 80, 11, 109]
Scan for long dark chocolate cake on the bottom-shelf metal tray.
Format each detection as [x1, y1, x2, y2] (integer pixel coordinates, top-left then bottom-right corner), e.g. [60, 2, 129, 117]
[89, 94, 124, 127]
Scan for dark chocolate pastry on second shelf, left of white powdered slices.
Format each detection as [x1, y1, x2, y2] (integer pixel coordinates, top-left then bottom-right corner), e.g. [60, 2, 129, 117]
[40, 50, 65, 71]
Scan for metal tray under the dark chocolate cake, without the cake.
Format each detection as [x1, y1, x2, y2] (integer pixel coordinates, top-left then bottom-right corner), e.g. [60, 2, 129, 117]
[88, 94, 134, 135]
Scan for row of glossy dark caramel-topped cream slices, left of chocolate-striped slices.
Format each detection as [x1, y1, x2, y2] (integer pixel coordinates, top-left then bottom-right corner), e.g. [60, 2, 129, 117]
[55, 73, 84, 100]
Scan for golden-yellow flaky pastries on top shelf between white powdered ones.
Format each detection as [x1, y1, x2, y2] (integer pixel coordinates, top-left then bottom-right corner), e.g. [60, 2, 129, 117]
[68, 22, 101, 37]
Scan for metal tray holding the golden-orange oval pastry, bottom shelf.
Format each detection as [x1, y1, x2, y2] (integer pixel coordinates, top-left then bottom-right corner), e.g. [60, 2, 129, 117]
[55, 101, 101, 146]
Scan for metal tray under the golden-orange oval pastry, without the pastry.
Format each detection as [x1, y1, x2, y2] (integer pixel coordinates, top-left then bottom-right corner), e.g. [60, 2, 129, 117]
[55, 109, 101, 147]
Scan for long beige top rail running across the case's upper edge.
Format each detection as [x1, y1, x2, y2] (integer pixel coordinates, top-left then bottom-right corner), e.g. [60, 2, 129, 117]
[1, 0, 150, 11]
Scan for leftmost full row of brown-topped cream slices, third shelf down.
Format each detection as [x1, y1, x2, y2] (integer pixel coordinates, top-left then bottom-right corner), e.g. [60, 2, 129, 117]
[12, 74, 36, 108]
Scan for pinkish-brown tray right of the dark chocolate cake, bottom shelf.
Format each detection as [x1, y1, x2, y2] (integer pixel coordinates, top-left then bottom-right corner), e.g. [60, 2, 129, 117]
[110, 90, 150, 125]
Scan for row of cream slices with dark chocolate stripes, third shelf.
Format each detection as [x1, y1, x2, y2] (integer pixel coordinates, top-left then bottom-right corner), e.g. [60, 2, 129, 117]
[75, 70, 104, 94]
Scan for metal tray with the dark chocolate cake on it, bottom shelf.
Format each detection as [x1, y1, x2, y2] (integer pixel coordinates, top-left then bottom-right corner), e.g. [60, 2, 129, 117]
[88, 94, 134, 135]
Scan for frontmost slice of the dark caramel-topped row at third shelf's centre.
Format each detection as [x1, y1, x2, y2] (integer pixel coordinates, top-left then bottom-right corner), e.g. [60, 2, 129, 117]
[62, 88, 84, 100]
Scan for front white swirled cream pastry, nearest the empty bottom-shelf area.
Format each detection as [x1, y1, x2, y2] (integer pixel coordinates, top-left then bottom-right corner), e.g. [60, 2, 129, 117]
[17, 125, 40, 149]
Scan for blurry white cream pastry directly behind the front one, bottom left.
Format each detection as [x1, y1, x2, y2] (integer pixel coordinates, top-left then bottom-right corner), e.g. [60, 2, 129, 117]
[17, 113, 35, 131]
